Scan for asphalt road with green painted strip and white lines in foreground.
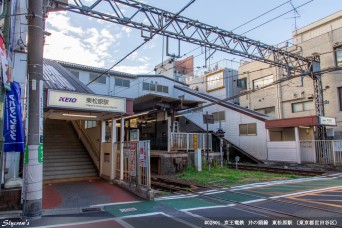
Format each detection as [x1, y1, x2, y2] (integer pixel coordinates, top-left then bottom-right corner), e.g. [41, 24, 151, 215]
[0, 174, 342, 228]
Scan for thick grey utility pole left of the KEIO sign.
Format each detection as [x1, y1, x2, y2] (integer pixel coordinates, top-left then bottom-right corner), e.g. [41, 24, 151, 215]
[23, 0, 44, 219]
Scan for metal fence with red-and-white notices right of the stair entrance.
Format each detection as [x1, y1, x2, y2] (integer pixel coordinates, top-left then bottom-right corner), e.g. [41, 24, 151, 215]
[115, 140, 151, 188]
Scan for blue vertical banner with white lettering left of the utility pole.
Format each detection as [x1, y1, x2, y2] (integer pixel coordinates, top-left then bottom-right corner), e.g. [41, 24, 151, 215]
[3, 82, 24, 152]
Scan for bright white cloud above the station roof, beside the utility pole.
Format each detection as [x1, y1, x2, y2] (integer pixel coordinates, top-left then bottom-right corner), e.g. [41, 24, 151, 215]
[44, 13, 122, 67]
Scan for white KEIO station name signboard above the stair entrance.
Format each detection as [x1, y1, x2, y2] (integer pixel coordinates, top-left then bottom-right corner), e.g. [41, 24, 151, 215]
[47, 90, 126, 113]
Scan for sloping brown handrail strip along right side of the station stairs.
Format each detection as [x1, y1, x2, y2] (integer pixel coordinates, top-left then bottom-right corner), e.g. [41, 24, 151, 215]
[71, 121, 100, 169]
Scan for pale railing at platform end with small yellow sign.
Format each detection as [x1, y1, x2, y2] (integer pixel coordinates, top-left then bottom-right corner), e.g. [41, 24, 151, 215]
[171, 133, 212, 151]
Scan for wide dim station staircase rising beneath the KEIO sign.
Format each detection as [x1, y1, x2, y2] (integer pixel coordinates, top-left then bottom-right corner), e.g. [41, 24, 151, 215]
[43, 119, 98, 180]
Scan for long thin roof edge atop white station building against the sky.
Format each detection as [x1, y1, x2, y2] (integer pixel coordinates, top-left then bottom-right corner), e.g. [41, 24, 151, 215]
[52, 60, 137, 78]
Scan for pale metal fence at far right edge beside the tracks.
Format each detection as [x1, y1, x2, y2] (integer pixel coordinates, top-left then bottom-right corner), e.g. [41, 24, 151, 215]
[300, 140, 342, 165]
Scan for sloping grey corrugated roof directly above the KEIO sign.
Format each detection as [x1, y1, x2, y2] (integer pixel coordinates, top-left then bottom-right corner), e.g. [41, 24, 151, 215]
[43, 59, 94, 94]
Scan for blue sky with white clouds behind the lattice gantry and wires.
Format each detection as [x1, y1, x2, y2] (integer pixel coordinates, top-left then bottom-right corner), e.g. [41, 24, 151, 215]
[44, 0, 342, 73]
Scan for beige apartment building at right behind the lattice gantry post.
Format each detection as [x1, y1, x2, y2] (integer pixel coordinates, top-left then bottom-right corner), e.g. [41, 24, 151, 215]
[238, 11, 342, 139]
